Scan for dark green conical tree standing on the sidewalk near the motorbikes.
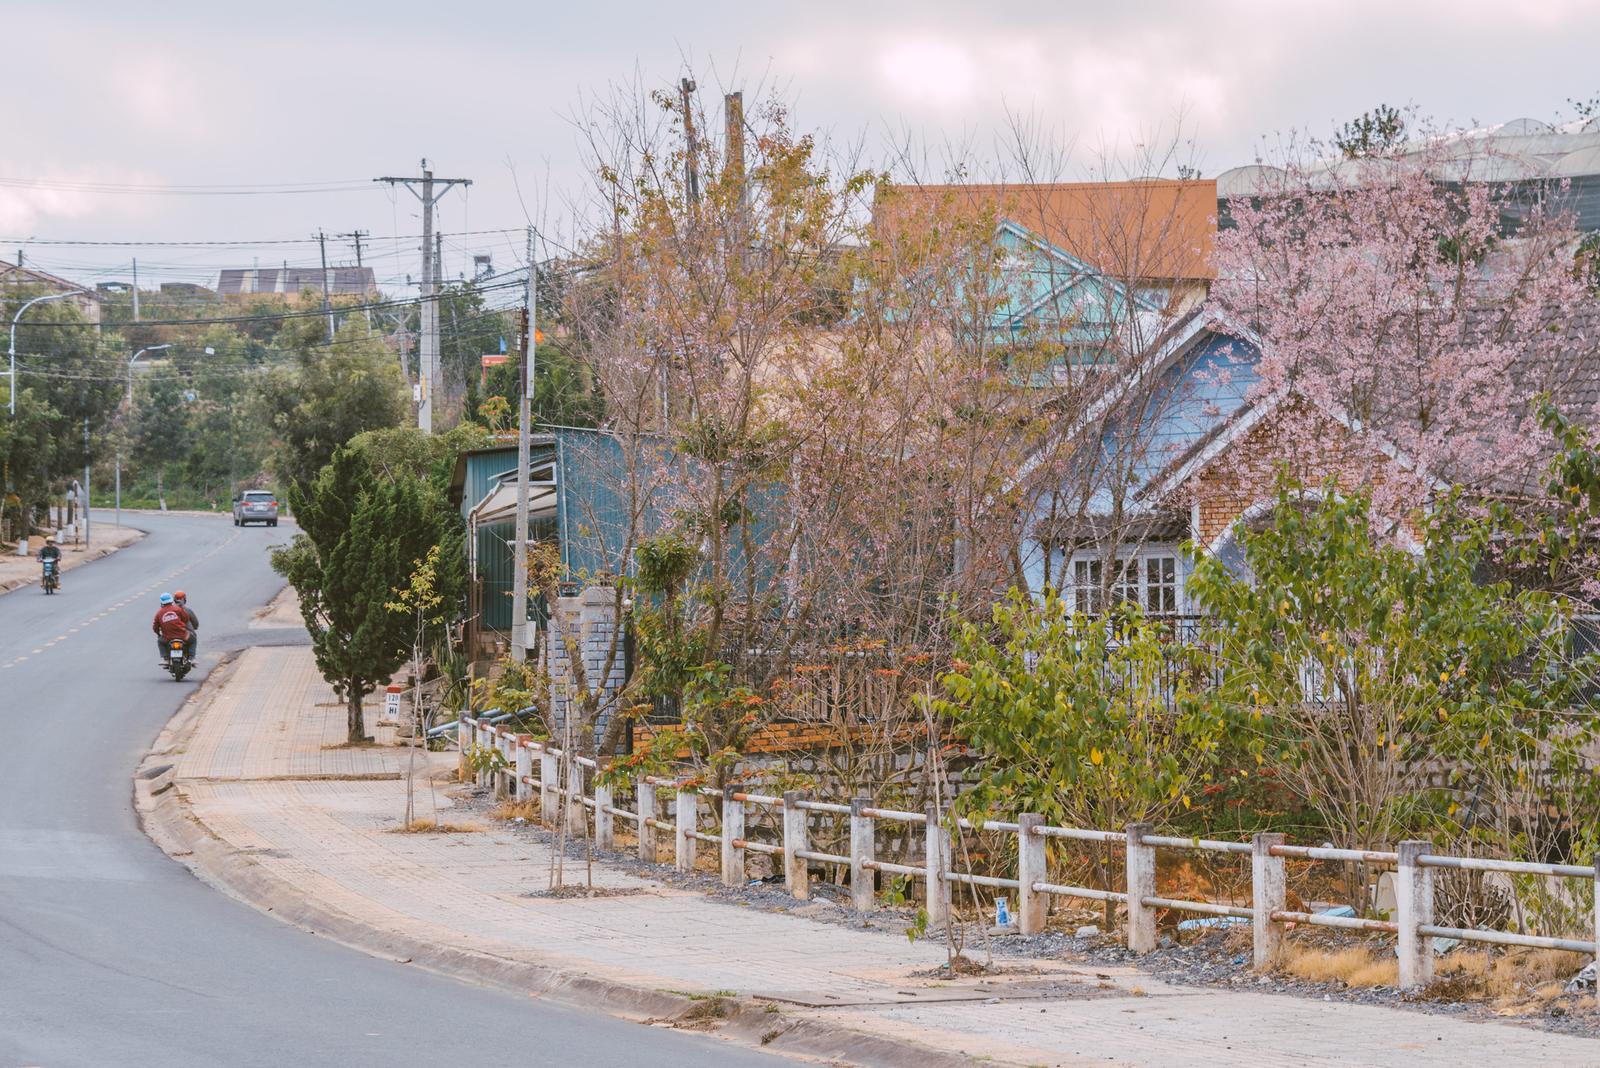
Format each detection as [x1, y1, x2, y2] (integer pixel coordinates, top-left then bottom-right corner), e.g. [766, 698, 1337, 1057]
[272, 448, 462, 743]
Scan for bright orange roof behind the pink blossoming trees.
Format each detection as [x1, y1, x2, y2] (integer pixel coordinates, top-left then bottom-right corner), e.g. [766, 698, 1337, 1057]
[874, 179, 1216, 280]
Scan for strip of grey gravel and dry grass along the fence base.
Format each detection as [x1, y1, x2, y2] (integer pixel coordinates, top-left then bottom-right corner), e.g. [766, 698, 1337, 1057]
[458, 788, 1600, 1038]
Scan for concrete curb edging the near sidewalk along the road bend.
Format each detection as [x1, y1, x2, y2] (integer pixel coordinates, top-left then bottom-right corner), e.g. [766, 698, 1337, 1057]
[133, 652, 995, 1068]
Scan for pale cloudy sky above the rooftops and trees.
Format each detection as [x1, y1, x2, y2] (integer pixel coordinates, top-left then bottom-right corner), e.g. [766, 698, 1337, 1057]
[9, 0, 1600, 294]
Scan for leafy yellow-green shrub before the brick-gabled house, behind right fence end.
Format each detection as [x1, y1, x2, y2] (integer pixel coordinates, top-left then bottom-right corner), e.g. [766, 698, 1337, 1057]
[1189, 481, 1595, 902]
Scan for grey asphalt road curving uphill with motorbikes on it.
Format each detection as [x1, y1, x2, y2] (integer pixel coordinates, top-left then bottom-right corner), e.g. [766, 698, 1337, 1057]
[0, 516, 781, 1068]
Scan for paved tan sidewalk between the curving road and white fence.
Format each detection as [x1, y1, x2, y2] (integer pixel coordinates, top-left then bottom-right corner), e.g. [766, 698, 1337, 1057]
[138, 648, 1600, 1068]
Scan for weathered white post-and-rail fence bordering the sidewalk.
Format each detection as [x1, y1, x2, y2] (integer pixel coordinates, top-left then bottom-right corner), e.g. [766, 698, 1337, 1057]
[456, 716, 1600, 1002]
